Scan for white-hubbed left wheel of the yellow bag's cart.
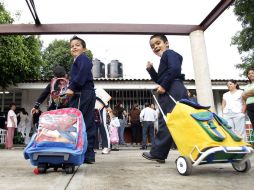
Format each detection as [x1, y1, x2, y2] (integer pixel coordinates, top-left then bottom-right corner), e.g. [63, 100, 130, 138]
[176, 156, 192, 176]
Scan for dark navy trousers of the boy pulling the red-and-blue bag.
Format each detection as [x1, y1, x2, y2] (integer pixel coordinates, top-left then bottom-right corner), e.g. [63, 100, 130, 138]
[70, 90, 96, 160]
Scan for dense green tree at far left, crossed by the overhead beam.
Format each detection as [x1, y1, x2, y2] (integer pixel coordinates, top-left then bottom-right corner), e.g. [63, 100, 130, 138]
[0, 3, 43, 89]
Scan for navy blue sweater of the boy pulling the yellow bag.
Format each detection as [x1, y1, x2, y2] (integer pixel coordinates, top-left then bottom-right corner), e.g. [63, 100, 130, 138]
[147, 49, 184, 91]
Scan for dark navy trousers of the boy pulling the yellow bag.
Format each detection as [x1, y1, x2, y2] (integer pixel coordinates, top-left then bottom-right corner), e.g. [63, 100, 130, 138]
[150, 80, 188, 159]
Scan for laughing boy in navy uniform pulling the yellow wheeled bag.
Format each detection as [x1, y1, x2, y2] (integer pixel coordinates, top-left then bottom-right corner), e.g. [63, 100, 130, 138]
[142, 34, 188, 163]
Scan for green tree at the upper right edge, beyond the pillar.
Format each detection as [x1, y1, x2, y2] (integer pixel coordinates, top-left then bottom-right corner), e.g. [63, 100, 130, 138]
[232, 0, 254, 74]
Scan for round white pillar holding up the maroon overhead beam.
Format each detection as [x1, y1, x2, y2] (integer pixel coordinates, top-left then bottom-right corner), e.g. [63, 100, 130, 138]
[190, 30, 215, 111]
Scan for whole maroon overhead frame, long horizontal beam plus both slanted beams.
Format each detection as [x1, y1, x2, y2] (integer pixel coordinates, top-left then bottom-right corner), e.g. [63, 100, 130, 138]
[0, 0, 234, 35]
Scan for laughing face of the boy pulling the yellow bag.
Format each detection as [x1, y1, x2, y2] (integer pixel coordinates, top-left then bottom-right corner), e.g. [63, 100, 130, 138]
[150, 37, 168, 57]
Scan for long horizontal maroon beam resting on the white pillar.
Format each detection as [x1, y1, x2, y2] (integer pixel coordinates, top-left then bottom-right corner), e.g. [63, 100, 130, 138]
[0, 23, 200, 35]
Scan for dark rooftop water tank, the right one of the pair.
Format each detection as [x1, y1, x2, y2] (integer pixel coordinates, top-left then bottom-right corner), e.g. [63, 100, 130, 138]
[108, 60, 123, 78]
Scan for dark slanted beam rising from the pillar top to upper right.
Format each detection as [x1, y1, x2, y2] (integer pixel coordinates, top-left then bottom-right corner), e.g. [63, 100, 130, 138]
[199, 0, 234, 31]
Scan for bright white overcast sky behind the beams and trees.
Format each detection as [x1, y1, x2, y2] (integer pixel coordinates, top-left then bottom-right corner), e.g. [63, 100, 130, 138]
[0, 0, 245, 79]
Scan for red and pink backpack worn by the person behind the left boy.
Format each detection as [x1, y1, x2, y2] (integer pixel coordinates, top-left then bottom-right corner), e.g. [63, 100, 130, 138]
[49, 77, 69, 109]
